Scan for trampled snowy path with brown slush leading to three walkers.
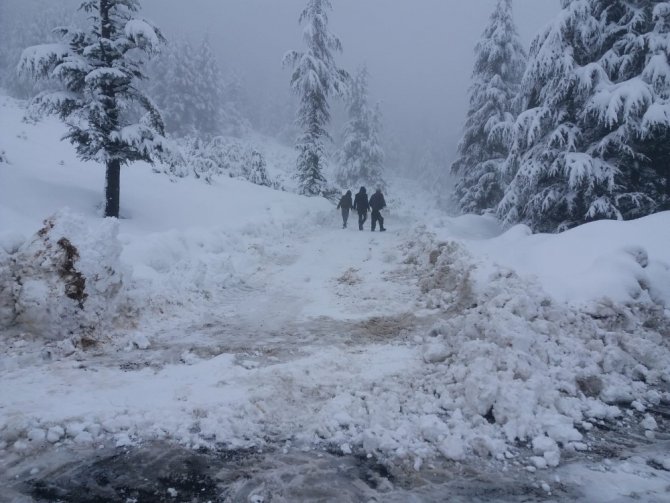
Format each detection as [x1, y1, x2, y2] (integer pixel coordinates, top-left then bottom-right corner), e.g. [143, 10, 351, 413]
[0, 209, 438, 456]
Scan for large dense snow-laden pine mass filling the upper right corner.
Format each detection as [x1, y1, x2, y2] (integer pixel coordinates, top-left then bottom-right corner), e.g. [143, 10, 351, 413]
[498, 0, 670, 231]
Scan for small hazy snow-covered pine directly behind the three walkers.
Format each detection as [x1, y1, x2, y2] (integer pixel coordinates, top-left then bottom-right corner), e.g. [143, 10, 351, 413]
[336, 67, 385, 188]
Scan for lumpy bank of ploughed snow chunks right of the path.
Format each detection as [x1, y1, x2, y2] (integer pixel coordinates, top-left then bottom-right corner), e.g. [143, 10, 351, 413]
[378, 231, 670, 467]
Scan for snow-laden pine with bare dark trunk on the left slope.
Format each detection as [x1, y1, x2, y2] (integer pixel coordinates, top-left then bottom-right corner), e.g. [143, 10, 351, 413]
[19, 0, 164, 218]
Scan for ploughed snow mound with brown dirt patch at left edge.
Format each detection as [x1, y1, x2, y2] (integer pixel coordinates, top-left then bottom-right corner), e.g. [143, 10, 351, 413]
[0, 211, 123, 343]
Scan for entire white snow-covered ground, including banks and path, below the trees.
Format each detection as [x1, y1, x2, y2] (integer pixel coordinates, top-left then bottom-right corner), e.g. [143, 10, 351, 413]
[0, 93, 670, 501]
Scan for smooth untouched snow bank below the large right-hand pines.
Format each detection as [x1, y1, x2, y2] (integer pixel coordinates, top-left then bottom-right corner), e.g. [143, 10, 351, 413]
[468, 211, 670, 306]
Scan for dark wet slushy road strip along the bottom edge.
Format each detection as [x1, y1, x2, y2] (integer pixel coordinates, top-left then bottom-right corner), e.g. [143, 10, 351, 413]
[0, 443, 577, 503]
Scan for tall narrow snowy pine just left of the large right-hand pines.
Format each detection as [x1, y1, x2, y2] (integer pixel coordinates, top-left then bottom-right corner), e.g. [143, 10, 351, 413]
[451, 0, 526, 214]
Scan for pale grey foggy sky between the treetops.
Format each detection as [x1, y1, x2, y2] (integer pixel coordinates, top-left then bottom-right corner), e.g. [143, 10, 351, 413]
[142, 0, 560, 159]
